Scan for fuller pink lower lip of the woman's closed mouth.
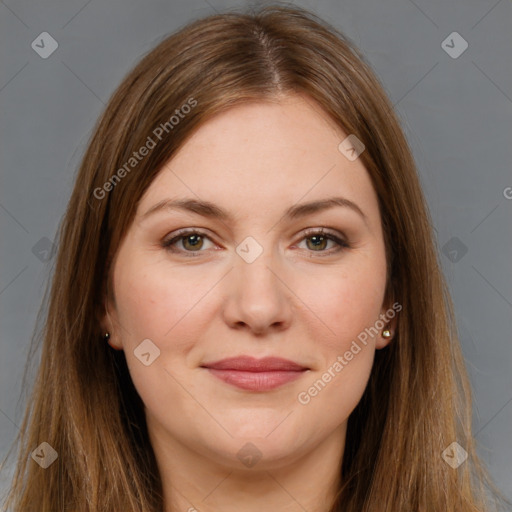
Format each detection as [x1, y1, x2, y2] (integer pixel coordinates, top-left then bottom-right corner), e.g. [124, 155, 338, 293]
[208, 368, 306, 391]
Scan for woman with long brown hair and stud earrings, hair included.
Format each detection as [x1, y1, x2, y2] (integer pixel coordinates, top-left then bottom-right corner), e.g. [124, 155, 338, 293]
[1, 7, 508, 512]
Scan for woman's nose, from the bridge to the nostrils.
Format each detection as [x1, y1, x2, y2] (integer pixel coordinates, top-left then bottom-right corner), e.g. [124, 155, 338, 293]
[223, 252, 293, 336]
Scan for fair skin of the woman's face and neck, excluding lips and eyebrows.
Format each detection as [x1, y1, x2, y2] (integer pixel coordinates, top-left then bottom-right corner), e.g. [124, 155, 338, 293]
[103, 95, 396, 512]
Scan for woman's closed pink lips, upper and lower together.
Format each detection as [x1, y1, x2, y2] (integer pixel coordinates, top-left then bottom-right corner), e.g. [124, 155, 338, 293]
[202, 356, 309, 391]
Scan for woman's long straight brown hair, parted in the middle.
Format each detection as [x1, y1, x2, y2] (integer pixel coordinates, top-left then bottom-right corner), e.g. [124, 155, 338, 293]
[1, 6, 508, 512]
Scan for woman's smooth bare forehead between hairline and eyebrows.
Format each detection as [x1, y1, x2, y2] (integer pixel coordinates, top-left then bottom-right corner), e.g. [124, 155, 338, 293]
[138, 96, 378, 230]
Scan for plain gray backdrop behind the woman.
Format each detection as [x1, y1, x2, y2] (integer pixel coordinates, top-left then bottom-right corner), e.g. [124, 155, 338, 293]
[0, 0, 512, 499]
